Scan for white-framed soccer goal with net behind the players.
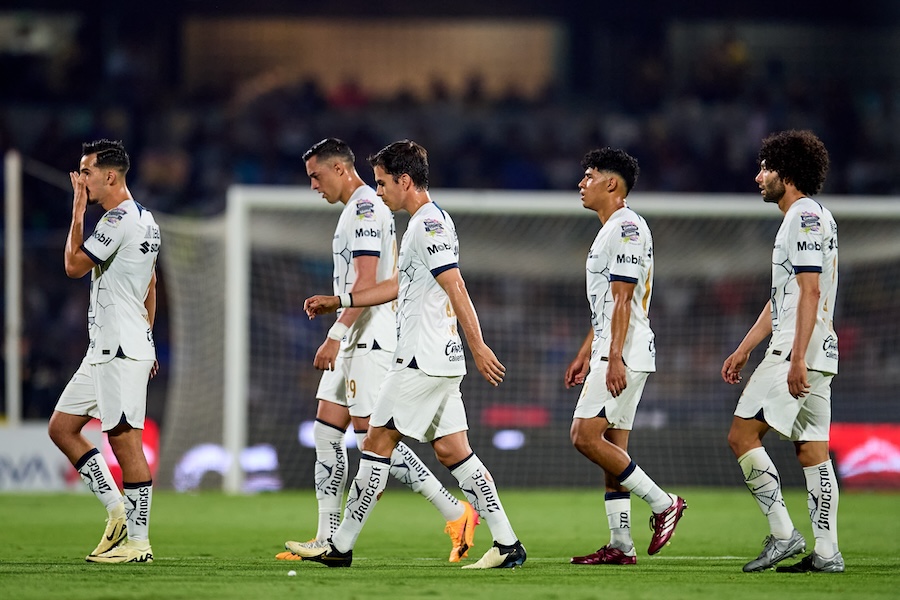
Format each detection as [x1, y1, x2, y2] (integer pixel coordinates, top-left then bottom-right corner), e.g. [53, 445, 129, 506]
[158, 186, 900, 491]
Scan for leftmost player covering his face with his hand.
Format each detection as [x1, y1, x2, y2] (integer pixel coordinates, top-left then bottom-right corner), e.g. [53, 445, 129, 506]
[49, 140, 160, 563]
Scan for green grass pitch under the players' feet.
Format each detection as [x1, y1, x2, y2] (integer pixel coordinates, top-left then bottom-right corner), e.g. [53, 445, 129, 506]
[0, 487, 900, 600]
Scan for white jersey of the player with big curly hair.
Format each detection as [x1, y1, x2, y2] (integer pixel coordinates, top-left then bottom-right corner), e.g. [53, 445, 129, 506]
[769, 198, 838, 373]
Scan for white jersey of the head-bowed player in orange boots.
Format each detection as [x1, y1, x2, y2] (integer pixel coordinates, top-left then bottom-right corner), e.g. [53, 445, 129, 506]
[331, 185, 397, 356]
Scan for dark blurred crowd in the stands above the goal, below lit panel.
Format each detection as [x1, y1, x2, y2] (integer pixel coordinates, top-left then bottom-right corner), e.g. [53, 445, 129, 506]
[0, 8, 900, 418]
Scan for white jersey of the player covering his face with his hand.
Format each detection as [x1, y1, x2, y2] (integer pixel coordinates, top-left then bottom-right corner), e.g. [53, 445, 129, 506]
[81, 200, 160, 364]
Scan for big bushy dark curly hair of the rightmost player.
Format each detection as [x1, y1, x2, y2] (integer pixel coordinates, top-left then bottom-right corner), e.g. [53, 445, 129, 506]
[759, 129, 829, 196]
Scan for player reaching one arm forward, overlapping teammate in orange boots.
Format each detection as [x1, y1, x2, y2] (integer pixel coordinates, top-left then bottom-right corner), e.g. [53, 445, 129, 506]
[287, 140, 525, 569]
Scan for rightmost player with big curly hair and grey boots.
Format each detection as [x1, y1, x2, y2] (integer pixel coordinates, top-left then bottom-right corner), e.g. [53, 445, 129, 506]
[722, 130, 844, 573]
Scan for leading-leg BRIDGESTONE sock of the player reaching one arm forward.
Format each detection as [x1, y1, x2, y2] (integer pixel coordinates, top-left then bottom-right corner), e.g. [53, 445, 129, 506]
[331, 450, 391, 552]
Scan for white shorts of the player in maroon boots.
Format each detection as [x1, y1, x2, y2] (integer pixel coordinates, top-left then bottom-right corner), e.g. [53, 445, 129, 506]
[574, 361, 649, 431]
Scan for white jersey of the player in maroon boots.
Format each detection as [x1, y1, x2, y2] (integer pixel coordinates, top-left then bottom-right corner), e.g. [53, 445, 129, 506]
[586, 206, 656, 372]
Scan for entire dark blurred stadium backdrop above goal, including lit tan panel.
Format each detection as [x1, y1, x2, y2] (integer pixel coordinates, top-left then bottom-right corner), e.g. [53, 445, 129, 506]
[0, 0, 900, 492]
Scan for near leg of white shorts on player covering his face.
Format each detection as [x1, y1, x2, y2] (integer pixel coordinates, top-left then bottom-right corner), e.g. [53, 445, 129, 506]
[91, 358, 154, 431]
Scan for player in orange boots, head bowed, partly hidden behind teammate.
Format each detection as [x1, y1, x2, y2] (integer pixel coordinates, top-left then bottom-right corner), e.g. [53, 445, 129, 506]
[276, 138, 478, 562]
